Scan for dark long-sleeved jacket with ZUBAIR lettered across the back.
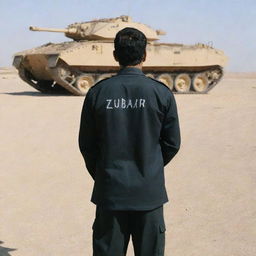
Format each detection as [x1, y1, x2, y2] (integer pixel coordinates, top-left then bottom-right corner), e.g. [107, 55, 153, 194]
[79, 68, 180, 256]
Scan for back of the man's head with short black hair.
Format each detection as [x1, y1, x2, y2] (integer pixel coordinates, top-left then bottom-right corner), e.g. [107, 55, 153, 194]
[114, 27, 147, 66]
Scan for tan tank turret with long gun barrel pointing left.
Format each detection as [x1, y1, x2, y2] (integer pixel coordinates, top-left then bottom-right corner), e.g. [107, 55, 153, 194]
[29, 16, 165, 41]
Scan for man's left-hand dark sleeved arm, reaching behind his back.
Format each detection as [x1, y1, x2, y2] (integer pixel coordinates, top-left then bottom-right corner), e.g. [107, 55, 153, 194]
[79, 90, 97, 179]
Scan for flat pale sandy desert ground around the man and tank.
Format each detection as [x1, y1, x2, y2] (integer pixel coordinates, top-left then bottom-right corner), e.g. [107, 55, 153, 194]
[0, 70, 256, 256]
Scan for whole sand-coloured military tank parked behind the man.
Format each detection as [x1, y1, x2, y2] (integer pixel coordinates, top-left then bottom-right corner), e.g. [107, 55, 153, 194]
[13, 16, 227, 95]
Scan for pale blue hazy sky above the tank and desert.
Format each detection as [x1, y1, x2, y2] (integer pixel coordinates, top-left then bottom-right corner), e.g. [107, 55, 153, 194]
[0, 0, 256, 72]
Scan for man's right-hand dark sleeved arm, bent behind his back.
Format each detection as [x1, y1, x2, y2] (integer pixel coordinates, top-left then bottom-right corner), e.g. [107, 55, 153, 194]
[160, 92, 180, 165]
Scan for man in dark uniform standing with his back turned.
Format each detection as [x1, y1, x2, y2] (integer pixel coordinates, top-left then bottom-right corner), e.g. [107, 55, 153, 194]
[79, 28, 180, 256]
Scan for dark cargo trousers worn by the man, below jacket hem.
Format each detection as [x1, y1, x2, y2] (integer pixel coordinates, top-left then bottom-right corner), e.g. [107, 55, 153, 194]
[93, 206, 165, 256]
